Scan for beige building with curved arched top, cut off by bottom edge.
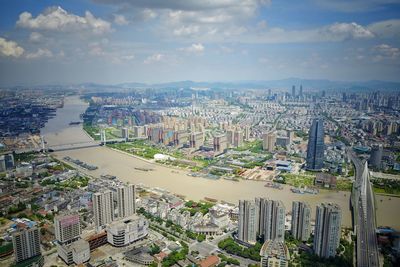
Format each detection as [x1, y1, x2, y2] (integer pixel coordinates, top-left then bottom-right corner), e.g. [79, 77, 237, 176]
[260, 240, 290, 267]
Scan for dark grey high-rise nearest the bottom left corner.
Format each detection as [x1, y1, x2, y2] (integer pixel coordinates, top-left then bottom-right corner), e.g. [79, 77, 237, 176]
[12, 223, 43, 266]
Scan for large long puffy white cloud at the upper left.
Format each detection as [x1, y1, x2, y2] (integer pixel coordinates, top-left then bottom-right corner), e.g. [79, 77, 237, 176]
[17, 6, 111, 34]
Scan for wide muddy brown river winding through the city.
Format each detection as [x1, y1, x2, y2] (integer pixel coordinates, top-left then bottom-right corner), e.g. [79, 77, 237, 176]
[42, 96, 400, 229]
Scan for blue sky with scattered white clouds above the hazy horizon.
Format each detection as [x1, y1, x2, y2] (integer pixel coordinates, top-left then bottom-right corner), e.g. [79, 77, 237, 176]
[0, 0, 400, 86]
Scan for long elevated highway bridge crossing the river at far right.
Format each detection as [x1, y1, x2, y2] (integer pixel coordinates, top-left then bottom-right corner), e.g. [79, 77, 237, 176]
[348, 151, 379, 267]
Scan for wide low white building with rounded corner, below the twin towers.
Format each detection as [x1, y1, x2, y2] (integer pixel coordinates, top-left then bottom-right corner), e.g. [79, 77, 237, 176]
[107, 215, 149, 247]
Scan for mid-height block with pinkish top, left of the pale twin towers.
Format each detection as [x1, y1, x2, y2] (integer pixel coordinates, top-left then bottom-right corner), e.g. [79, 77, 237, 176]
[54, 214, 82, 244]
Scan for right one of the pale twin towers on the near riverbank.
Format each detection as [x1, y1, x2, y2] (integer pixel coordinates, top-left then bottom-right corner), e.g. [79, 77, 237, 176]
[117, 184, 136, 218]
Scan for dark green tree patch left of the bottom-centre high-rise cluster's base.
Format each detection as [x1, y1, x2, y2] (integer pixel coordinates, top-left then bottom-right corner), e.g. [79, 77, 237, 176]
[218, 238, 262, 261]
